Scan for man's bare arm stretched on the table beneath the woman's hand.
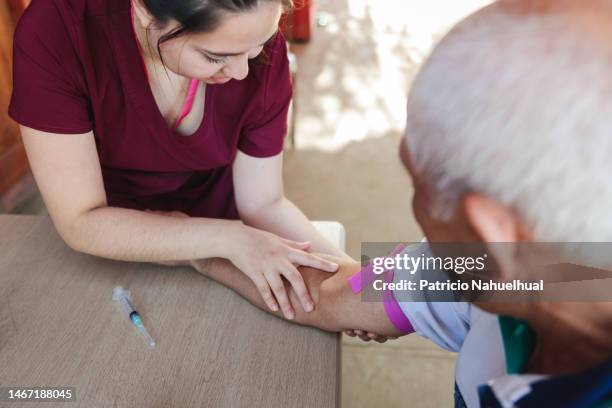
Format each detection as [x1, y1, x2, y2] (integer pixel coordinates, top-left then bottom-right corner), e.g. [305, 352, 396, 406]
[192, 259, 400, 337]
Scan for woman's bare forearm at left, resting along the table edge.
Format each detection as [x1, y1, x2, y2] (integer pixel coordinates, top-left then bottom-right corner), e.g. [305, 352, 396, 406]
[60, 207, 242, 262]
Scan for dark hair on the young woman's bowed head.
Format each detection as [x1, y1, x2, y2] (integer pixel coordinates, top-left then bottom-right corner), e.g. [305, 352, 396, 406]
[142, 0, 293, 56]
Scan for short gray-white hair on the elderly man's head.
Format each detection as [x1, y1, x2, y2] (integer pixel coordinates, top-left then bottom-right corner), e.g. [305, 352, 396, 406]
[406, 0, 612, 242]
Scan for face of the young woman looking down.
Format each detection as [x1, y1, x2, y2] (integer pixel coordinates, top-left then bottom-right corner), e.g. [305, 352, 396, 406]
[142, 1, 282, 84]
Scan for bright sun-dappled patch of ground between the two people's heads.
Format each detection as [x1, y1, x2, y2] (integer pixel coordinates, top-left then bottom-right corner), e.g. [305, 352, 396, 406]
[293, 0, 489, 149]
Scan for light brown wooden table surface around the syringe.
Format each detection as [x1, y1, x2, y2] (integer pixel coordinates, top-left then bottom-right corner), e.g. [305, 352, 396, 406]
[0, 215, 340, 408]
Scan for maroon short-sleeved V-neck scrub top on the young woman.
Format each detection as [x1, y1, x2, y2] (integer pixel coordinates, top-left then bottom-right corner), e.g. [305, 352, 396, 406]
[9, 0, 291, 219]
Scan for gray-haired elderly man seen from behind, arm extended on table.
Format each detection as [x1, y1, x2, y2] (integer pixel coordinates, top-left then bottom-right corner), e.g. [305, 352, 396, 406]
[166, 0, 612, 407]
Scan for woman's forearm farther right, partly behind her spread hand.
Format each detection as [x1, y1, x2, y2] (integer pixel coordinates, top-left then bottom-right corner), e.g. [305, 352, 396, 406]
[242, 198, 352, 260]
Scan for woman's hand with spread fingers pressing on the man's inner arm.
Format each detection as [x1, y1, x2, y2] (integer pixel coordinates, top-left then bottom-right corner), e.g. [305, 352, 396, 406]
[227, 225, 339, 319]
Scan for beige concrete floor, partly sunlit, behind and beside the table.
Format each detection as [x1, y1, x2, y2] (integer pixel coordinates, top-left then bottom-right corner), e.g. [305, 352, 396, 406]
[4, 0, 489, 408]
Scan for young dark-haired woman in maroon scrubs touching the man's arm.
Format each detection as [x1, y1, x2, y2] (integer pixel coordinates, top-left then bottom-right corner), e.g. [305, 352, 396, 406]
[9, 0, 342, 318]
